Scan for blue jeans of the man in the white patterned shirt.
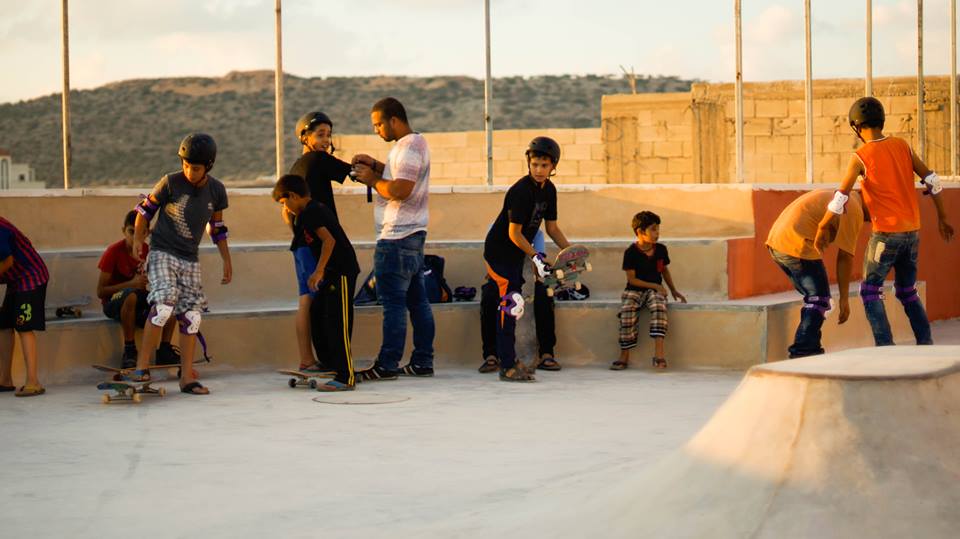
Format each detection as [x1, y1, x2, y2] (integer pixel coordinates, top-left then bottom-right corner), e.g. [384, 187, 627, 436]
[373, 232, 435, 371]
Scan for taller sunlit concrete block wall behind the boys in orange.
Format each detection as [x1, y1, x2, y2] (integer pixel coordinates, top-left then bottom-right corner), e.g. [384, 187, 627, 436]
[601, 77, 950, 183]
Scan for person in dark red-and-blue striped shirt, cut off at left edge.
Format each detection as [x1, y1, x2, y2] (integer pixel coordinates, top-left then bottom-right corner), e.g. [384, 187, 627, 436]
[0, 217, 50, 397]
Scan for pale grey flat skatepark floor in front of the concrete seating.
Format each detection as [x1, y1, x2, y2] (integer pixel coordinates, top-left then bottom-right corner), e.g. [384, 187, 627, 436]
[0, 320, 960, 538]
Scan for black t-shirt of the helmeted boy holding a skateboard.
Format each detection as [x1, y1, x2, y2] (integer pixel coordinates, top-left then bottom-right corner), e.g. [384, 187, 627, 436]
[483, 175, 557, 264]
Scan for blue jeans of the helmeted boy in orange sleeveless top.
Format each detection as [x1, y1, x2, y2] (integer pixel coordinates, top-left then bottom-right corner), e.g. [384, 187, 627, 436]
[860, 231, 933, 346]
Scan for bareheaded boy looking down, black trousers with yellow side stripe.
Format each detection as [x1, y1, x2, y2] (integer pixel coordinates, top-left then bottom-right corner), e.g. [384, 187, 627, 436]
[273, 174, 360, 391]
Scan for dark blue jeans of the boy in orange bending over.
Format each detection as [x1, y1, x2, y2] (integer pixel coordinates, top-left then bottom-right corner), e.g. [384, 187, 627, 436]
[768, 248, 830, 358]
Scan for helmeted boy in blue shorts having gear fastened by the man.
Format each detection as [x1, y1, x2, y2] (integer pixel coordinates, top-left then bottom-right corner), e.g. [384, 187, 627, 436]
[281, 111, 350, 371]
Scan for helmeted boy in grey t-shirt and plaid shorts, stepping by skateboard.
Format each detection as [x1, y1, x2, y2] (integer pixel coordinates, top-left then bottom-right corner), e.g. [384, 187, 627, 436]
[131, 133, 233, 395]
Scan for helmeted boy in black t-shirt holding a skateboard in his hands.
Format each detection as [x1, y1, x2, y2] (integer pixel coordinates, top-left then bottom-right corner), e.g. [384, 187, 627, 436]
[483, 137, 569, 382]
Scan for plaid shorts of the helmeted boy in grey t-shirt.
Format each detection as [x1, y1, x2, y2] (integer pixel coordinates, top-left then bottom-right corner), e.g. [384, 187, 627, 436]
[147, 250, 207, 314]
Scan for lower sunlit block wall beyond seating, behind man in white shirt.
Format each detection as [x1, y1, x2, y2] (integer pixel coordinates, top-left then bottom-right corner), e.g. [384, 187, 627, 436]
[333, 128, 607, 185]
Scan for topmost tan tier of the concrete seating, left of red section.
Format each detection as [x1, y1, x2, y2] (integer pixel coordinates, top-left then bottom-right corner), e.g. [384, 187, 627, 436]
[0, 185, 753, 249]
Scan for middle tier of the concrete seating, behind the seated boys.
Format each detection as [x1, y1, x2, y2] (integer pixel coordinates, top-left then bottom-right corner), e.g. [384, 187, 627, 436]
[41, 238, 740, 312]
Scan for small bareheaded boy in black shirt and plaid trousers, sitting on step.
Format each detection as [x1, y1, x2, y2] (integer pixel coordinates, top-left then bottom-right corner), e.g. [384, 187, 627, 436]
[610, 211, 687, 371]
